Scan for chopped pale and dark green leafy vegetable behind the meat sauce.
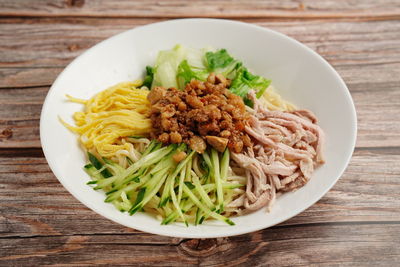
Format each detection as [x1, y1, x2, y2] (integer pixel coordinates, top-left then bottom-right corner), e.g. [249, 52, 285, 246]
[144, 45, 271, 106]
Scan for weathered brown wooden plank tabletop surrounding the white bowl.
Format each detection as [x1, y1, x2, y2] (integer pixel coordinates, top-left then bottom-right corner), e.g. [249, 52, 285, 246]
[0, 0, 400, 266]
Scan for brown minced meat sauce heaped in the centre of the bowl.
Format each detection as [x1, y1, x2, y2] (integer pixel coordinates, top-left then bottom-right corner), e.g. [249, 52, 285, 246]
[148, 74, 251, 153]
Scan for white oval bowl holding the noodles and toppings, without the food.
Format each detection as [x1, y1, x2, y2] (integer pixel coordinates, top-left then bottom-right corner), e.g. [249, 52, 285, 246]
[40, 19, 357, 238]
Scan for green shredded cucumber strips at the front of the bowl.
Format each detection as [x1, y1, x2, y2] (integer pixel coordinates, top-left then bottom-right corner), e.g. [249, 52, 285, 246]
[84, 141, 243, 226]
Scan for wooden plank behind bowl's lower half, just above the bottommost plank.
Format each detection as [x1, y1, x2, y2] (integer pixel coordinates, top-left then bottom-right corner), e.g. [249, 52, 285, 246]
[0, 150, 400, 240]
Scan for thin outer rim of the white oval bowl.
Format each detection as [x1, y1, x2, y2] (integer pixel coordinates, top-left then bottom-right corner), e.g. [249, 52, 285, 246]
[40, 18, 357, 238]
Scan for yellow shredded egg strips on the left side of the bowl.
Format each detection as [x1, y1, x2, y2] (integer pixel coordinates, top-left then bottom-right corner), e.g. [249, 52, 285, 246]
[61, 81, 151, 158]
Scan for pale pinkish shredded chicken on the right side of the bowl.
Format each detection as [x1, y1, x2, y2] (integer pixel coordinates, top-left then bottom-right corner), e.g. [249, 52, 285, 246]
[231, 92, 324, 212]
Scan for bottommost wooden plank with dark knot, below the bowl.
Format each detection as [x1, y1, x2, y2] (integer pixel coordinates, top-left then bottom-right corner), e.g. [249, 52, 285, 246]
[0, 224, 400, 266]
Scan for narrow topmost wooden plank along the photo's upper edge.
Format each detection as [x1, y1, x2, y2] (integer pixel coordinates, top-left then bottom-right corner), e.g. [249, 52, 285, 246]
[0, 0, 400, 19]
